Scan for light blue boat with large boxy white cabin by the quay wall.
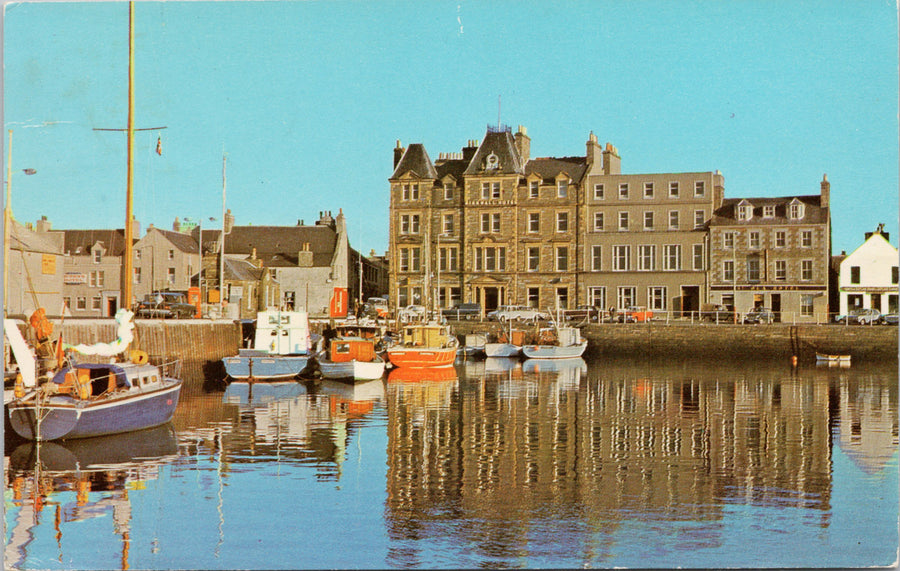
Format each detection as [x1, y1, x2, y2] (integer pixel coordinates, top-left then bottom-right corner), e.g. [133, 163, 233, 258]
[222, 310, 312, 380]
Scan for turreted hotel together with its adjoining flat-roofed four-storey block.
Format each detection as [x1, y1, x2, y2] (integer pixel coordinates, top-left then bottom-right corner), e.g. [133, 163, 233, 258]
[390, 126, 724, 311]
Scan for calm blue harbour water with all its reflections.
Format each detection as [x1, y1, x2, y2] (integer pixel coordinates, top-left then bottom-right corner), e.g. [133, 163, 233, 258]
[4, 359, 898, 569]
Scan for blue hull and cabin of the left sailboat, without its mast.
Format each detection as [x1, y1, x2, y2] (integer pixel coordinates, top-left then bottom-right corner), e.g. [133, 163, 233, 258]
[7, 355, 182, 440]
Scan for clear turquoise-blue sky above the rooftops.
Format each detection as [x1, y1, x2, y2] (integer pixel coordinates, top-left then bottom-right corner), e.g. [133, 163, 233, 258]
[3, 0, 900, 253]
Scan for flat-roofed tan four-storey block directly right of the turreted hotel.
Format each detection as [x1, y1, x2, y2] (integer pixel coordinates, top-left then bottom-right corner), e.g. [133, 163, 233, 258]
[577, 140, 724, 316]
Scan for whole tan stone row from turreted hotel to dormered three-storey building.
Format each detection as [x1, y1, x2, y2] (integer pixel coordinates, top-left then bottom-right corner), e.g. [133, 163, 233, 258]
[389, 126, 831, 321]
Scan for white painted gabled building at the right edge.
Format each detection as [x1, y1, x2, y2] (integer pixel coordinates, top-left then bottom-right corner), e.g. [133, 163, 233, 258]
[838, 226, 900, 314]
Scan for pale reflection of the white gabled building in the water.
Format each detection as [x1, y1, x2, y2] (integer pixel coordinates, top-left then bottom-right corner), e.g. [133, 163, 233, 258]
[836, 376, 900, 474]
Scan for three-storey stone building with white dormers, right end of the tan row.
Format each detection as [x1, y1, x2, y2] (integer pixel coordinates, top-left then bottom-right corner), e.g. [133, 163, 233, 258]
[709, 176, 831, 323]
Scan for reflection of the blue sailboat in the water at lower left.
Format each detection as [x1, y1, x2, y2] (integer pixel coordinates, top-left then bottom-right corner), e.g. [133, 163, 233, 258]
[5, 424, 178, 569]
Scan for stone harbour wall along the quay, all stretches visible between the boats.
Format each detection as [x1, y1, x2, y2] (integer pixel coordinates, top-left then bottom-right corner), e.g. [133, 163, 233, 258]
[31, 319, 898, 384]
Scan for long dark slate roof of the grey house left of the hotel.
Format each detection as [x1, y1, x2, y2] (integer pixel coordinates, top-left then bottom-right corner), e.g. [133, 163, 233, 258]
[224, 225, 337, 268]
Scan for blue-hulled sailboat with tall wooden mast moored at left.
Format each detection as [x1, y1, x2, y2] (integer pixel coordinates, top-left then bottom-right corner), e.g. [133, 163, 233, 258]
[4, 2, 182, 440]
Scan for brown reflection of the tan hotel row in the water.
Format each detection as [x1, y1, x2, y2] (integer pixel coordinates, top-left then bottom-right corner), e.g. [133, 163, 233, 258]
[387, 362, 831, 564]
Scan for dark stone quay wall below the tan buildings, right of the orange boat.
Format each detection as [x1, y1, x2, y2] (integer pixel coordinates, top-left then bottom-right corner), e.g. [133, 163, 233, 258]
[453, 322, 898, 362]
